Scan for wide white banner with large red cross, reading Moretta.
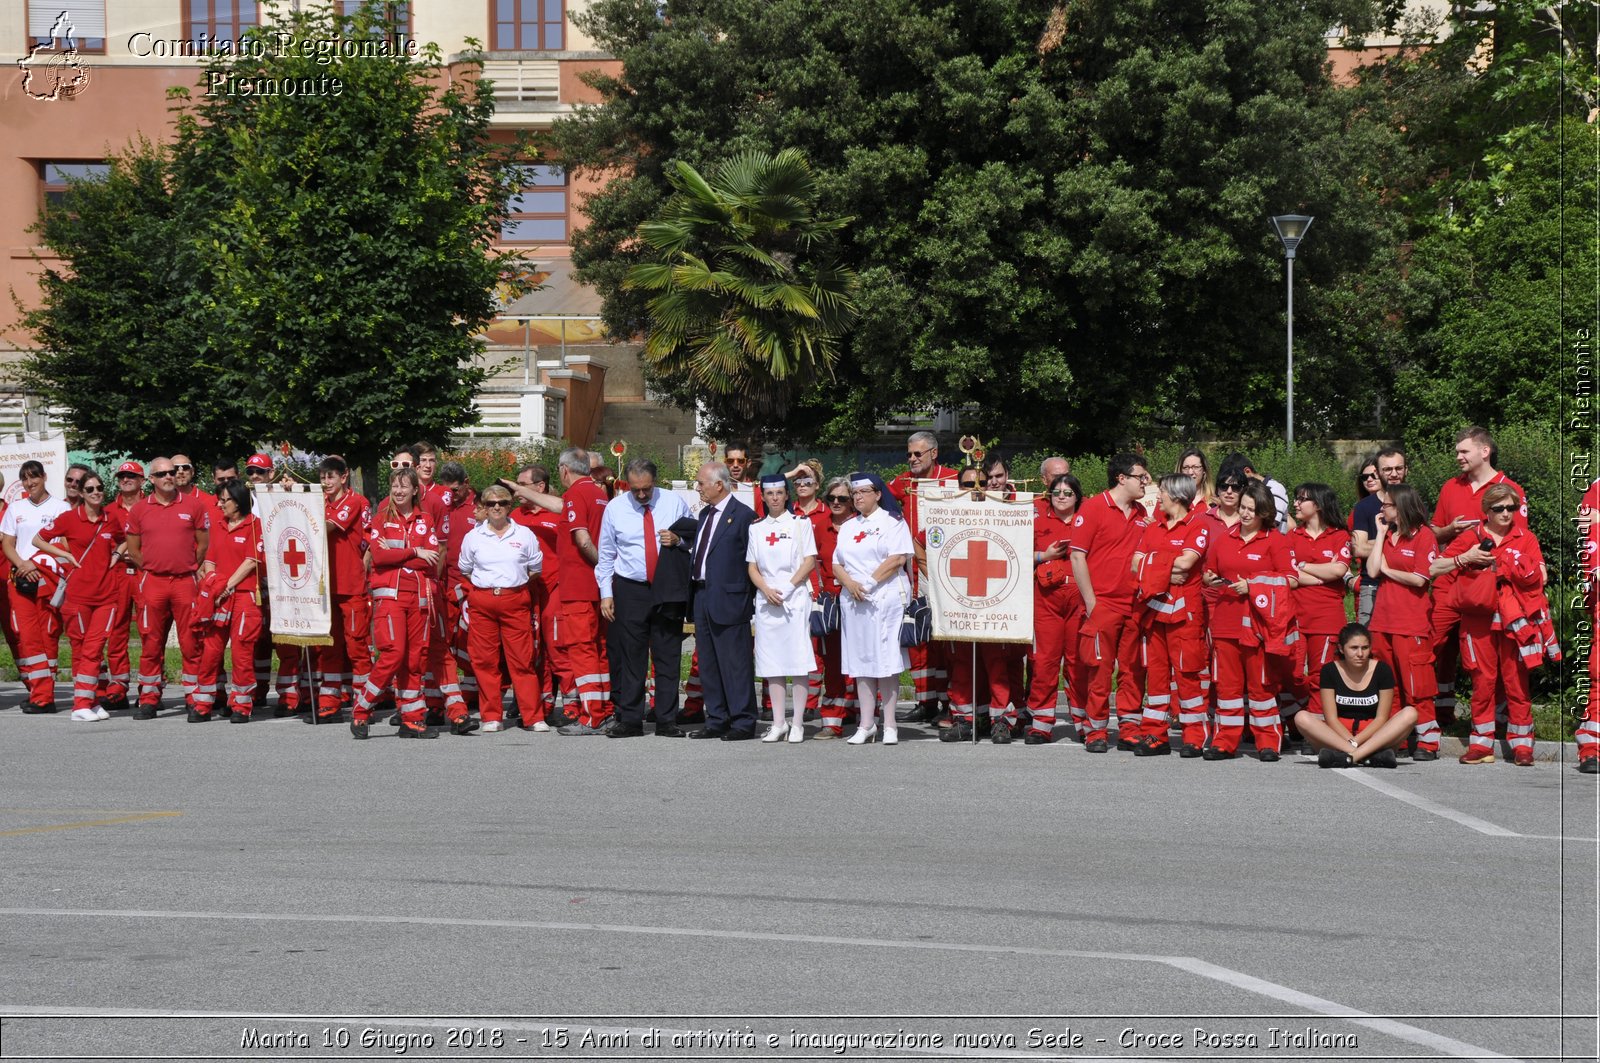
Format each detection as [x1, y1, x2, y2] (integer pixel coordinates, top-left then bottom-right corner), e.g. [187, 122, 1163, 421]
[917, 485, 1034, 644]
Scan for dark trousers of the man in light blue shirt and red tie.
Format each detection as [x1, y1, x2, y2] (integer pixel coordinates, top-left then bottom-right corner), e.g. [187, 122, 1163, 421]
[606, 576, 683, 725]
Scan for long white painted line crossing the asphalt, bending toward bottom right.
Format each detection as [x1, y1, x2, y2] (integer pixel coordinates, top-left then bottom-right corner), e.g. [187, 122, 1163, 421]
[0, 902, 1512, 1060]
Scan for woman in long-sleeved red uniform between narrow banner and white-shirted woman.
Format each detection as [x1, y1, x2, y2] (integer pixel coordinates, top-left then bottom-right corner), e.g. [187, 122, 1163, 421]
[350, 467, 444, 738]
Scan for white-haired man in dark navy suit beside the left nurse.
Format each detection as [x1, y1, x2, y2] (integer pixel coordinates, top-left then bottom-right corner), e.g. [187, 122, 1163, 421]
[690, 461, 755, 741]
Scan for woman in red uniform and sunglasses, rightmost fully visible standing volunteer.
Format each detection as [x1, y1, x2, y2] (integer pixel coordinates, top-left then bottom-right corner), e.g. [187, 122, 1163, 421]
[1432, 483, 1550, 767]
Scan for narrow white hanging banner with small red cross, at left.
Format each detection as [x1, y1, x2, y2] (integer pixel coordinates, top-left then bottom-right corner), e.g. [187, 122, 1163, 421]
[251, 483, 333, 645]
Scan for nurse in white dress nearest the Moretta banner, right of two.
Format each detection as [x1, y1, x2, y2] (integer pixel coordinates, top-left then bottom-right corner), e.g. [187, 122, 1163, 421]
[834, 472, 912, 746]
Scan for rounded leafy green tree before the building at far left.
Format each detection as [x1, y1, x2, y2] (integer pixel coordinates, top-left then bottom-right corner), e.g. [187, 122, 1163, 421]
[27, 3, 518, 463]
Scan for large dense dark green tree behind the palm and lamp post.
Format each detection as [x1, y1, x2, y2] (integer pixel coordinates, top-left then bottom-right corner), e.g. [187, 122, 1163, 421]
[554, 0, 1398, 448]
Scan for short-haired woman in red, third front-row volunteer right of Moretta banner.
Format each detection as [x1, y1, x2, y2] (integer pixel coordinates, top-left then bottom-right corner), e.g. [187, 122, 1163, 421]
[1133, 472, 1211, 757]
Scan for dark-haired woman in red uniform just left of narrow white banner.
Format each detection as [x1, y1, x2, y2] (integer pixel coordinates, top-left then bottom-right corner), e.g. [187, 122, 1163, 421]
[189, 479, 267, 724]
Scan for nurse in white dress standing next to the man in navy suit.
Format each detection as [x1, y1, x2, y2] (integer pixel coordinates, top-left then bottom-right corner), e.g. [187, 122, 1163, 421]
[744, 475, 816, 741]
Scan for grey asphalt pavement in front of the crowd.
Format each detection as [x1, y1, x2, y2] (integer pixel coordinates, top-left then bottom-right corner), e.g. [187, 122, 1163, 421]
[0, 692, 1600, 1060]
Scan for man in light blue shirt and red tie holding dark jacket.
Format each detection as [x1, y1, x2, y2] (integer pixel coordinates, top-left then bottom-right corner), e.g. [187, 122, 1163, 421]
[595, 458, 698, 738]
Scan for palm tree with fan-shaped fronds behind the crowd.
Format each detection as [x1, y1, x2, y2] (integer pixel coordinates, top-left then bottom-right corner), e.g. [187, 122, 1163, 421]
[624, 149, 856, 423]
